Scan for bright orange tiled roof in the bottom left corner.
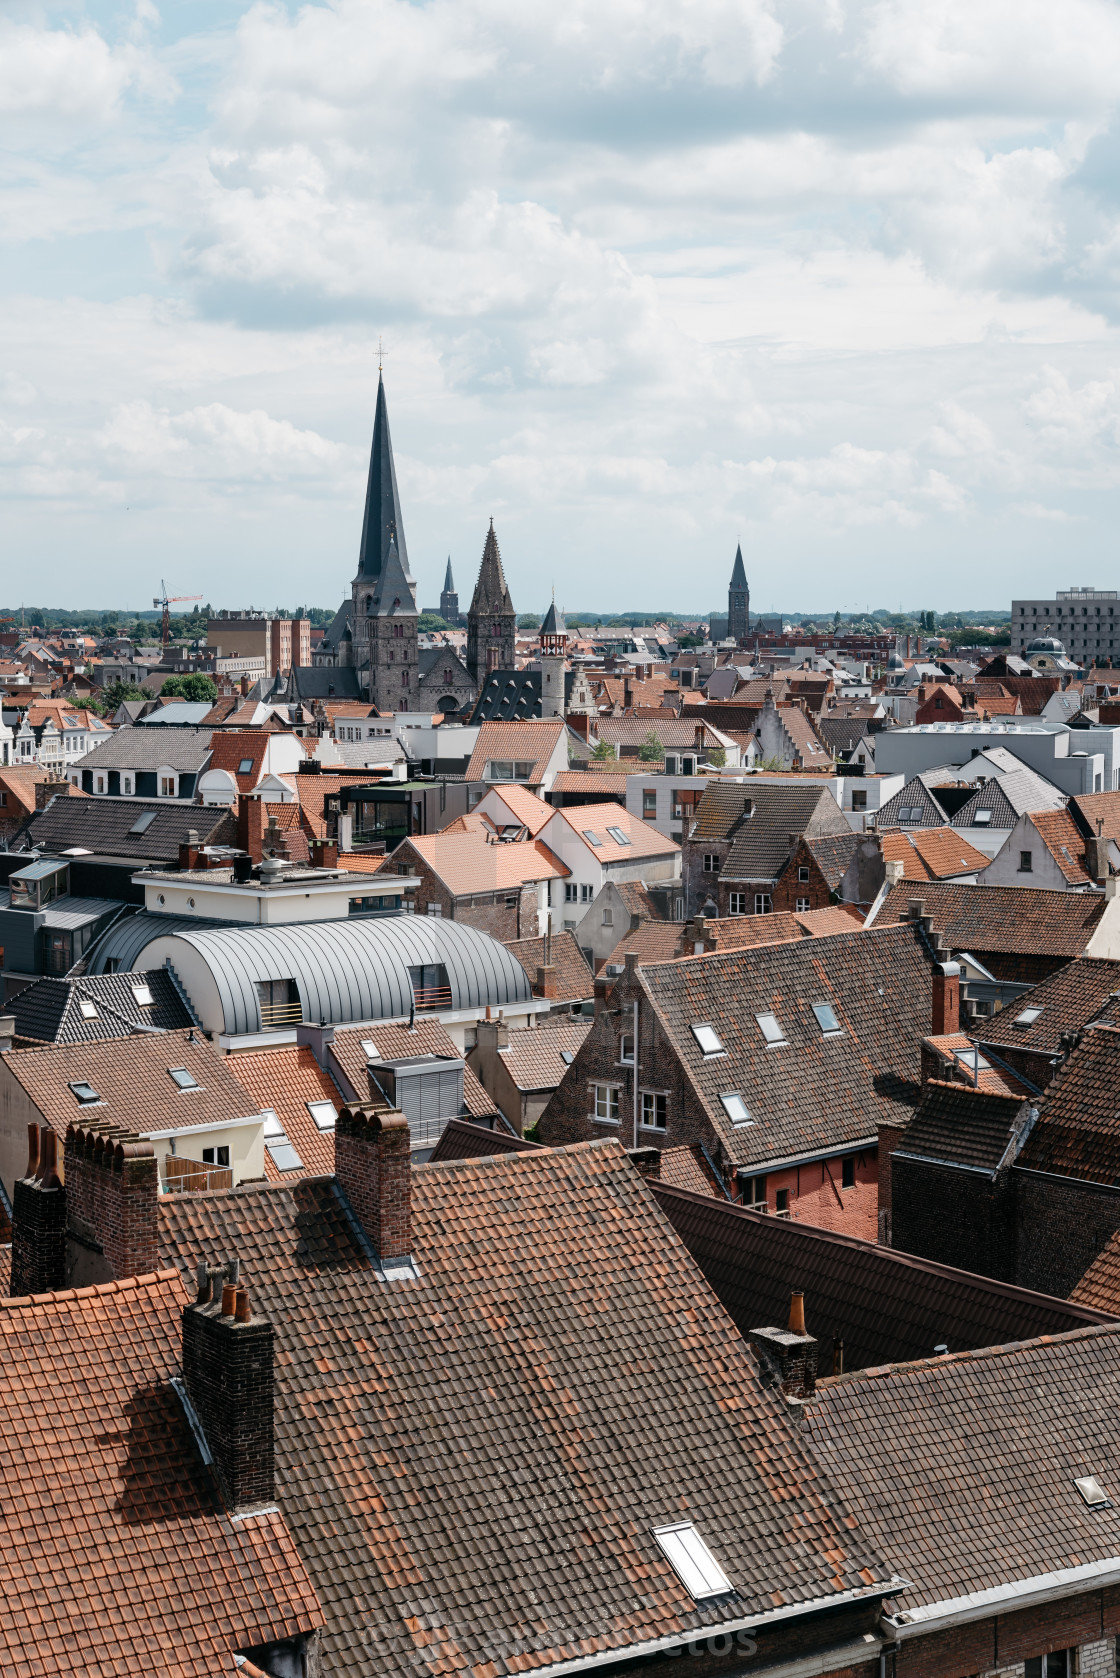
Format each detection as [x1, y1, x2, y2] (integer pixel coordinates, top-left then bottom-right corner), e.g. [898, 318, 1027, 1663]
[0, 1270, 322, 1678]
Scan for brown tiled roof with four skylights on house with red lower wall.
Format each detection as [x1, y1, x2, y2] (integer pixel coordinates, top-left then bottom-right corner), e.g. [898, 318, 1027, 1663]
[634, 926, 932, 1170]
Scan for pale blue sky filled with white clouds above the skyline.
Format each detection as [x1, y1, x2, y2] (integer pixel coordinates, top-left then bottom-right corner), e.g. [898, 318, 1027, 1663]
[0, 0, 1120, 612]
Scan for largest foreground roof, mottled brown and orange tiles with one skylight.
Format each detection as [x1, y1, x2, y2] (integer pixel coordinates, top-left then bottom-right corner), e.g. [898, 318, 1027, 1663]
[160, 1143, 890, 1678]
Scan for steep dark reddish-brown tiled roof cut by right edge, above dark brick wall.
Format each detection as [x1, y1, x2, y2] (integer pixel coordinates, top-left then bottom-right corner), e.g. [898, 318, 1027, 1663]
[1016, 1025, 1120, 1185]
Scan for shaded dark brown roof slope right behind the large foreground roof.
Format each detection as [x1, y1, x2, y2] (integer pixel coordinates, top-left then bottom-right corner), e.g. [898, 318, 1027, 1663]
[650, 1181, 1112, 1376]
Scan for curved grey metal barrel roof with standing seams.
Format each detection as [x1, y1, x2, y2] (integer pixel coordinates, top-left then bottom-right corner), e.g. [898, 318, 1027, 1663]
[109, 915, 532, 1034]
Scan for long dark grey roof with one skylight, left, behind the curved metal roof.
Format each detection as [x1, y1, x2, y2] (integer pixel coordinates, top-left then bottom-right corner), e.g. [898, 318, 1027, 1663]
[20, 797, 237, 866]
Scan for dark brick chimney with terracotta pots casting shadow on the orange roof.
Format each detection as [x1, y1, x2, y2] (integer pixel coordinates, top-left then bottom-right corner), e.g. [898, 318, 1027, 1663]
[183, 1264, 275, 1512]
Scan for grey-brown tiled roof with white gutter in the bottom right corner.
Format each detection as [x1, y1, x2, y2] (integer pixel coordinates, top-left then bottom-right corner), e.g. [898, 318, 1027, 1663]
[806, 1326, 1120, 1611]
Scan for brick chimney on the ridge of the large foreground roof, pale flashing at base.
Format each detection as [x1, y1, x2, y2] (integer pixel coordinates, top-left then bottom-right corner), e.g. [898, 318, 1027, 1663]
[334, 1106, 411, 1264]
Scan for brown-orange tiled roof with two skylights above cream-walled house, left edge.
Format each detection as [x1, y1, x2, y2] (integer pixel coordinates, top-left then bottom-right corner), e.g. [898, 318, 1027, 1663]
[3, 1032, 257, 1138]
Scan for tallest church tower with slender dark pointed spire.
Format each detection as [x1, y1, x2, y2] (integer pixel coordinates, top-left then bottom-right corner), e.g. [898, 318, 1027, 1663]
[351, 373, 420, 711]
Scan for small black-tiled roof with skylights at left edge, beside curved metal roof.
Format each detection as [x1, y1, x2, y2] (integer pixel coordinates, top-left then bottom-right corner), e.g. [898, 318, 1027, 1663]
[5, 968, 195, 1044]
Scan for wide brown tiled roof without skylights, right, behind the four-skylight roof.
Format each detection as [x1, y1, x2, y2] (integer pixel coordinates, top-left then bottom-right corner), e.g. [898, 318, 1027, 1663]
[875, 881, 1105, 960]
